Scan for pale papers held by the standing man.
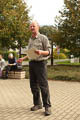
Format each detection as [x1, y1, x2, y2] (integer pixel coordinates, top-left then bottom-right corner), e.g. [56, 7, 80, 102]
[27, 48, 40, 60]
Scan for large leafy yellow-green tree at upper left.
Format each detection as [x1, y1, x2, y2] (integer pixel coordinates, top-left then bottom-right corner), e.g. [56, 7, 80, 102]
[0, 0, 30, 57]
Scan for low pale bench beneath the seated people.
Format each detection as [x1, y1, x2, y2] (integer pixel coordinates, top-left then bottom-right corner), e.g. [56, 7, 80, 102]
[2, 71, 26, 79]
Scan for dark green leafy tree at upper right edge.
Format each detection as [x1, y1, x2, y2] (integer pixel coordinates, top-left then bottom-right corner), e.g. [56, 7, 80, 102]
[56, 0, 80, 56]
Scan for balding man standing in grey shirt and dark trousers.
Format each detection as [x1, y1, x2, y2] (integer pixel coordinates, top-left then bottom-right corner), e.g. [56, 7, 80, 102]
[21, 22, 51, 116]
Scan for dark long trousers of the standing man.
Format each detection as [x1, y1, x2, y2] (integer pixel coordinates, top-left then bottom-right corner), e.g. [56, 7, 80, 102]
[29, 61, 51, 107]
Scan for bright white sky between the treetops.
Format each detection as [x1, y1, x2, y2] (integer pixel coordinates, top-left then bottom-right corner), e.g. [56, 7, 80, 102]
[25, 0, 64, 25]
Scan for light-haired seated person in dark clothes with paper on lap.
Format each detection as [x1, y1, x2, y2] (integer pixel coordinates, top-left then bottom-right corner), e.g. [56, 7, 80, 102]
[6, 53, 17, 78]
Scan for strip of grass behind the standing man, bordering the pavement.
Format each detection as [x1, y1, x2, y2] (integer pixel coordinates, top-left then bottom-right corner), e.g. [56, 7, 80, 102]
[24, 65, 80, 81]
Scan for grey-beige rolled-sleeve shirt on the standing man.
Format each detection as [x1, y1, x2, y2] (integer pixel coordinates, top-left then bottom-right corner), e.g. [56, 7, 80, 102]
[28, 33, 51, 61]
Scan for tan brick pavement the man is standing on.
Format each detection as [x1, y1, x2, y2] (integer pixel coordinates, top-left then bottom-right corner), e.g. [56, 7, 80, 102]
[0, 79, 80, 120]
